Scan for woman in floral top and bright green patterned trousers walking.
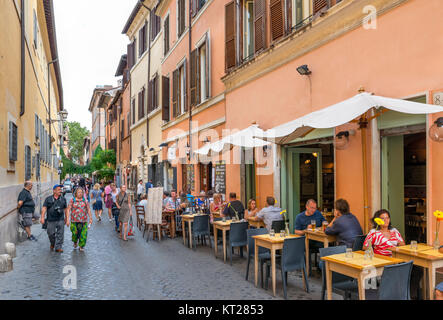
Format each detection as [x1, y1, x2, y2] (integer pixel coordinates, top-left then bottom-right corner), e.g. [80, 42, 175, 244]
[68, 188, 92, 251]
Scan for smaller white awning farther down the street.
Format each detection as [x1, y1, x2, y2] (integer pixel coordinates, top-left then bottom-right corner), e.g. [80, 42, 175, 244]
[194, 124, 270, 155]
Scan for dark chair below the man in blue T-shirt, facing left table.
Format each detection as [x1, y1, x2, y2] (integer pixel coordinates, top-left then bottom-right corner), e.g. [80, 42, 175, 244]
[266, 236, 309, 299]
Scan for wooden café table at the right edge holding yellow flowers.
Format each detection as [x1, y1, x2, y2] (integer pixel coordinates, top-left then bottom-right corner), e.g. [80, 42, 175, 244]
[389, 243, 443, 300]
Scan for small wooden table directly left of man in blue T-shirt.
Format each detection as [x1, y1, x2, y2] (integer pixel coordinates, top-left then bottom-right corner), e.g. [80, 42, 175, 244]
[252, 234, 304, 297]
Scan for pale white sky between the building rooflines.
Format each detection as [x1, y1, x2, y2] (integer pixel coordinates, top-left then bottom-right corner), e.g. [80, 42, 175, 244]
[54, 0, 137, 131]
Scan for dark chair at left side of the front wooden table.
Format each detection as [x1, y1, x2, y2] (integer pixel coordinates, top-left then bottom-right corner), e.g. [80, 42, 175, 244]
[319, 246, 358, 300]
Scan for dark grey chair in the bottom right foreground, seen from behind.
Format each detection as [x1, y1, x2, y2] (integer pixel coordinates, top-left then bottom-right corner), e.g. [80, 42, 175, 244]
[352, 260, 413, 300]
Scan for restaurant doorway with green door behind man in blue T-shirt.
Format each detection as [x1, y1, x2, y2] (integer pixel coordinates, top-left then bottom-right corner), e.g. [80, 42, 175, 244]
[285, 143, 335, 228]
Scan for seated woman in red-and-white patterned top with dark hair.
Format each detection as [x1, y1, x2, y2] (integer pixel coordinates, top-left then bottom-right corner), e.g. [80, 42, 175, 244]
[363, 209, 405, 256]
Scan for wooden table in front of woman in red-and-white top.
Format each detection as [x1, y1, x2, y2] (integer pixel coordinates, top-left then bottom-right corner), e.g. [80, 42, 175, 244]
[321, 251, 404, 300]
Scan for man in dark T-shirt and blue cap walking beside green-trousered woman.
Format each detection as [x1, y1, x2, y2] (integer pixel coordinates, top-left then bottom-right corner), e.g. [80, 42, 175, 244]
[40, 184, 69, 253]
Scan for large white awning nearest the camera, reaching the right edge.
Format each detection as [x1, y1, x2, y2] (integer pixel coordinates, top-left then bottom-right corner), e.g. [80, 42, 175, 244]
[256, 92, 443, 144]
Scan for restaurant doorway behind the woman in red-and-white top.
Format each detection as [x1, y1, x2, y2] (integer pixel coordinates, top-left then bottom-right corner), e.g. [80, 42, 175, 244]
[381, 128, 426, 243]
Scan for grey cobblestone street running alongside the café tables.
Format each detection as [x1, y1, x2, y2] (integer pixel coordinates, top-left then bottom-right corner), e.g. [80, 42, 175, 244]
[0, 195, 340, 300]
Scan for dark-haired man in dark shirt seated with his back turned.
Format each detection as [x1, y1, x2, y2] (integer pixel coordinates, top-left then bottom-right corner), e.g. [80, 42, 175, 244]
[325, 199, 363, 248]
